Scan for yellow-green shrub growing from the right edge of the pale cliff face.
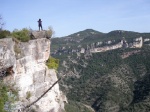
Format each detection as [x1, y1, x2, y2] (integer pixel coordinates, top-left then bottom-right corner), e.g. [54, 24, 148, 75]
[46, 57, 59, 70]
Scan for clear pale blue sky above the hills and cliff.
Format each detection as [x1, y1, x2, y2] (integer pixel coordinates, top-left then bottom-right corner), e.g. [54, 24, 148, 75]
[0, 0, 150, 37]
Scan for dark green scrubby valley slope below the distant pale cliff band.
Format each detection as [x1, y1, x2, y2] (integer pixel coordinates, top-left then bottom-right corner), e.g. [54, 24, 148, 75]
[56, 46, 150, 112]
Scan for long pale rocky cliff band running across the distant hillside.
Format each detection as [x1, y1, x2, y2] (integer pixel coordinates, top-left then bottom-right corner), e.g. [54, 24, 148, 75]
[52, 37, 144, 55]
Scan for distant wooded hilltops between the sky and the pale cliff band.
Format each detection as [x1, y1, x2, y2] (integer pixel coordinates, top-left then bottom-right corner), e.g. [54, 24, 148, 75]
[51, 29, 150, 52]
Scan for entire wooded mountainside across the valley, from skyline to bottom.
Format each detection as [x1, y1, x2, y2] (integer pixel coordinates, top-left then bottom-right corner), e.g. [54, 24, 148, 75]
[51, 29, 150, 112]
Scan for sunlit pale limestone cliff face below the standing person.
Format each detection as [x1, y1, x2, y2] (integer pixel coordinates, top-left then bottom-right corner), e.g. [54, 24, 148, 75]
[0, 32, 65, 112]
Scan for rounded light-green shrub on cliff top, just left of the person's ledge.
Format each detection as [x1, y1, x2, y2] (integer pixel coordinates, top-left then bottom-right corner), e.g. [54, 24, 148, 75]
[12, 28, 30, 42]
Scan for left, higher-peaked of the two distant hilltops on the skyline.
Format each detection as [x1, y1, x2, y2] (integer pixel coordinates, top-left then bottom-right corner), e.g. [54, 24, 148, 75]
[51, 29, 104, 52]
